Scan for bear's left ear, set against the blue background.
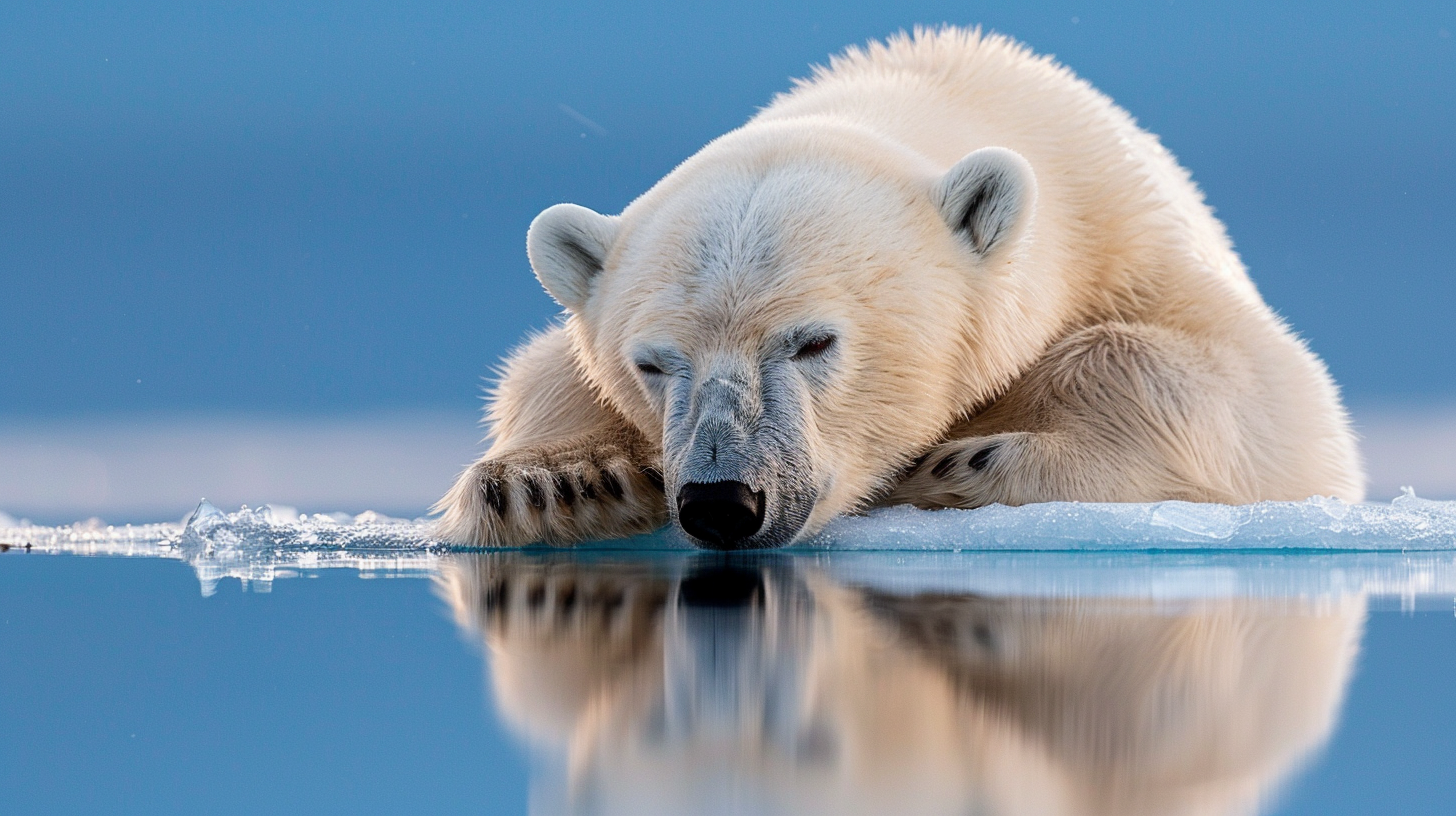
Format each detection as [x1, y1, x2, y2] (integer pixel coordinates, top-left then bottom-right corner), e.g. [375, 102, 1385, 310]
[526, 204, 617, 312]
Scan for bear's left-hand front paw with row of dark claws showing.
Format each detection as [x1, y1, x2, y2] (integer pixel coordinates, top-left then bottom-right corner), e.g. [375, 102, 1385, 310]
[435, 450, 667, 546]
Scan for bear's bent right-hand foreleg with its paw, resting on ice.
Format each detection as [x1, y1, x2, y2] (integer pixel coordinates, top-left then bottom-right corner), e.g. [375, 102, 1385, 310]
[885, 323, 1259, 509]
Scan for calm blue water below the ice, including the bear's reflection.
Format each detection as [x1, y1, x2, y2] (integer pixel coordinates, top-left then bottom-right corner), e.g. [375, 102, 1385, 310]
[0, 551, 1456, 815]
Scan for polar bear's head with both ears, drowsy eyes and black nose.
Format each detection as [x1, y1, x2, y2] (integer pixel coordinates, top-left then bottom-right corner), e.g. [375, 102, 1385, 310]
[527, 119, 1044, 548]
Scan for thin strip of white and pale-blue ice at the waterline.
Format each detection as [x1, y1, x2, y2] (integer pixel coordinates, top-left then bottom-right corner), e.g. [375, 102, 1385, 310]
[0, 490, 1456, 595]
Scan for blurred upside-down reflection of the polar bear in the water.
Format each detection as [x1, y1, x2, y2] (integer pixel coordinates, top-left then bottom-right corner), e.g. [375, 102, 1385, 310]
[441, 554, 1364, 816]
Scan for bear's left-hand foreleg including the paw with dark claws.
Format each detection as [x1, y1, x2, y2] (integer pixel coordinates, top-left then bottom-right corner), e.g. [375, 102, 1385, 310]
[434, 328, 667, 546]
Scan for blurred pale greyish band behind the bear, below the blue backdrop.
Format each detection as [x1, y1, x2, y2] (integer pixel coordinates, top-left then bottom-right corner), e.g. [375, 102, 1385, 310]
[0, 405, 1456, 525]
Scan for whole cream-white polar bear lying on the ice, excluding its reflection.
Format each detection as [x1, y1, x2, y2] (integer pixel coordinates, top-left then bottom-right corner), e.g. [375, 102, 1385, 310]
[435, 28, 1364, 548]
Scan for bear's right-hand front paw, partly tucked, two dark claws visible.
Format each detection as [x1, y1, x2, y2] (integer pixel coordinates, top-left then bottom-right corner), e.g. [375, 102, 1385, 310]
[885, 433, 1041, 510]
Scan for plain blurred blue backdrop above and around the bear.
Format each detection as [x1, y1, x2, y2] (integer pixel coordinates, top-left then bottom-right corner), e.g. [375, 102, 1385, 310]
[0, 0, 1456, 420]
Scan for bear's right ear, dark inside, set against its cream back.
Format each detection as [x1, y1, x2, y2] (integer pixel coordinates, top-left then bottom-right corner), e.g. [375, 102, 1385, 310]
[932, 147, 1037, 258]
